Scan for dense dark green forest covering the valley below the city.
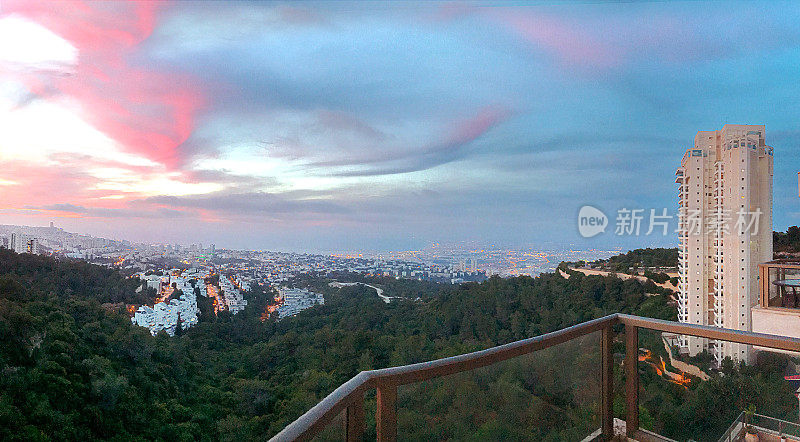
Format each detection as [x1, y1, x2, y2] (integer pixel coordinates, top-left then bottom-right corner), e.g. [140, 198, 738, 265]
[0, 250, 797, 441]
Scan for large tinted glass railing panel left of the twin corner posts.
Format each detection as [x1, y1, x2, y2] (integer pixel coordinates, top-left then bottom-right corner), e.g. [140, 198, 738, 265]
[398, 332, 601, 441]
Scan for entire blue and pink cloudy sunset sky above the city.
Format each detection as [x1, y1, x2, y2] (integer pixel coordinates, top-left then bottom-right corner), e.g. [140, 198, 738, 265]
[0, 0, 800, 252]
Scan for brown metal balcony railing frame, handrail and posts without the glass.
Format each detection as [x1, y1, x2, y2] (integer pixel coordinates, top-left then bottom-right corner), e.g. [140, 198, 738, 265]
[271, 313, 800, 441]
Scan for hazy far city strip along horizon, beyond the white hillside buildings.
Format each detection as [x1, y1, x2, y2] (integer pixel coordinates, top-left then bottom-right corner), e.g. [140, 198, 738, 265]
[0, 223, 622, 284]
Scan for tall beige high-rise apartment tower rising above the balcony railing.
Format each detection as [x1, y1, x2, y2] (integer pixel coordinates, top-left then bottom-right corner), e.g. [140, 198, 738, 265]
[675, 124, 773, 363]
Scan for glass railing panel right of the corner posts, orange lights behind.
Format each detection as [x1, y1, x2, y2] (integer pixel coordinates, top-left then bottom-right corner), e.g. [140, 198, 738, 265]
[638, 329, 800, 442]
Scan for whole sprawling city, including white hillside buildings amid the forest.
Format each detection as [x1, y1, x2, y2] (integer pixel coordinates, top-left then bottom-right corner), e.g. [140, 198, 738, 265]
[0, 223, 621, 336]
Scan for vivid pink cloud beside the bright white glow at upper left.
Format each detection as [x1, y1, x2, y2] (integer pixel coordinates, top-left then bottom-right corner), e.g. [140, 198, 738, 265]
[3, 0, 204, 169]
